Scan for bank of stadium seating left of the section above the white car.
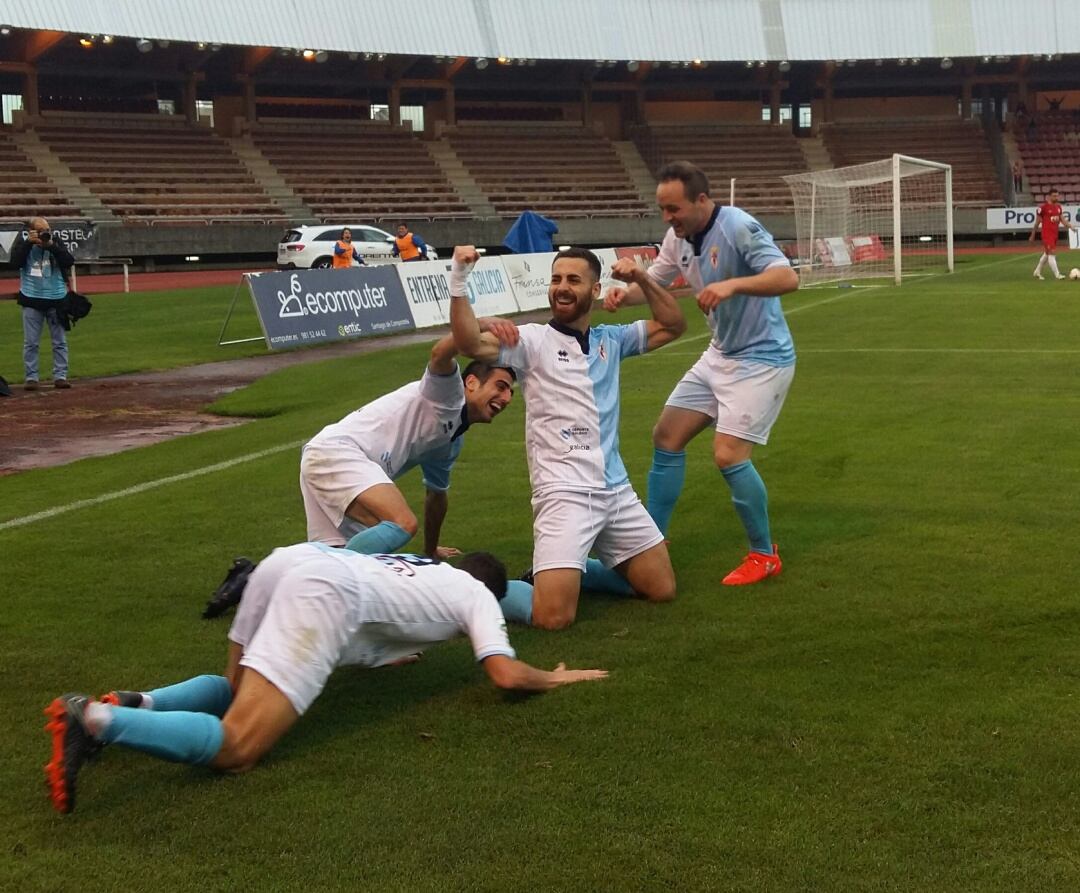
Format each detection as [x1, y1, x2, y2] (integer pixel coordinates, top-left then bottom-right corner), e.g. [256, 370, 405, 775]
[36, 112, 285, 224]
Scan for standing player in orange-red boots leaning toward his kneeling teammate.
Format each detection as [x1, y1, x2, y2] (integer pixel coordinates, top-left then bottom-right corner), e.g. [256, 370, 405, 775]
[604, 161, 799, 585]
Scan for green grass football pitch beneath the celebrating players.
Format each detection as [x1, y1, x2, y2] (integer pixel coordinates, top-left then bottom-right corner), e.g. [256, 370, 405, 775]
[0, 256, 1080, 892]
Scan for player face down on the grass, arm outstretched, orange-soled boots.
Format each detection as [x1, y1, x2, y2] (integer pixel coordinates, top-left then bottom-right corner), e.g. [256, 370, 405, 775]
[45, 543, 607, 812]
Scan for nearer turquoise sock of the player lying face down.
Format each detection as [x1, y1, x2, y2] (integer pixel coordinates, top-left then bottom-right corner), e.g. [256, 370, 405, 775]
[98, 707, 225, 766]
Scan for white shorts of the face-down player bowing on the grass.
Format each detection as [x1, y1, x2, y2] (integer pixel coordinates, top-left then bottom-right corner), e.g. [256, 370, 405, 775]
[229, 543, 360, 715]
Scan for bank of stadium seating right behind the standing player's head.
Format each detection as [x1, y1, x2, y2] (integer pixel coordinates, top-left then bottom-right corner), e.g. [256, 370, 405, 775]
[631, 124, 807, 214]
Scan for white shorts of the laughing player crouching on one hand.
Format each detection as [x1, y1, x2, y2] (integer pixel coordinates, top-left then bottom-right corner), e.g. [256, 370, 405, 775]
[300, 444, 393, 545]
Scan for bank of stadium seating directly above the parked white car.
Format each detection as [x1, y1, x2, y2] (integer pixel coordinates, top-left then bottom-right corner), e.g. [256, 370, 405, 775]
[251, 121, 472, 222]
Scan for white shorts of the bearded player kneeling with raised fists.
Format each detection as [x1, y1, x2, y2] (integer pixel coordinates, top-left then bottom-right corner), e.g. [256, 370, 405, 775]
[532, 484, 664, 573]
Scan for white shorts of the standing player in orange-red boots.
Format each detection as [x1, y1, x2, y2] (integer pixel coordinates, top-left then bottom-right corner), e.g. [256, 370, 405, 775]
[666, 344, 795, 444]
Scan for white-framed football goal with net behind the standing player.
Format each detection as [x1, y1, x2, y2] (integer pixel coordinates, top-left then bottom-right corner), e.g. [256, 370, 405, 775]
[784, 154, 953, 285]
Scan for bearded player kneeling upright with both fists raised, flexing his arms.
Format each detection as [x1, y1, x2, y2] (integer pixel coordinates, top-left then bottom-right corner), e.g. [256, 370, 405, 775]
[450, 245, 686, 630]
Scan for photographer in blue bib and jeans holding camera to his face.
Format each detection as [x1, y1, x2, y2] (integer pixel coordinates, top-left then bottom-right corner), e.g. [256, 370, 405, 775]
[11, 217, 75, 391]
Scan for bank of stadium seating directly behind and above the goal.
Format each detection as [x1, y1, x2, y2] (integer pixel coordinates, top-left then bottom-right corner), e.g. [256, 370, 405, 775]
[822, 118, 1003, 206]
